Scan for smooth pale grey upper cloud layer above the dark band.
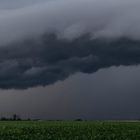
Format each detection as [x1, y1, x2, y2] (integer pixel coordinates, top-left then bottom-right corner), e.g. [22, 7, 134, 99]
[0, 0, 140, 44]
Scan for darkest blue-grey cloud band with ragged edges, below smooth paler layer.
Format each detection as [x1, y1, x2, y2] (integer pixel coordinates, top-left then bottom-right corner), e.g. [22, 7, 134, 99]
[0, 34, 140, 88]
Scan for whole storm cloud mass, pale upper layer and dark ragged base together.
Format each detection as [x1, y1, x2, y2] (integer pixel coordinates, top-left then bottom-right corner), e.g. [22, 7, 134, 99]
[0, 0, 140, 88]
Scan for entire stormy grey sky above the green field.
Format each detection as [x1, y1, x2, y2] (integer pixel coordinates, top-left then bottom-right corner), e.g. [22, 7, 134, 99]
[0, 0, 140, 120]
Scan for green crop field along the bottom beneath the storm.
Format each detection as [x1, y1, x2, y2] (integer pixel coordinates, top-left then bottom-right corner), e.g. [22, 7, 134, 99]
[0, 121, 140, 140]
